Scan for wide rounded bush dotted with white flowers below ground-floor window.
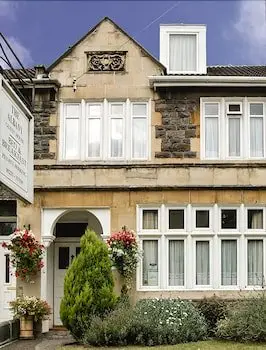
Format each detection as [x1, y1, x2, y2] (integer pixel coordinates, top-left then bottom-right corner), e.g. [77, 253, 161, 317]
[128, 299, 207, 346]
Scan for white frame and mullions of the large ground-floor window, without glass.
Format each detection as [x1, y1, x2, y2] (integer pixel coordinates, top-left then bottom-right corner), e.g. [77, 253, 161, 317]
[137, 204, 266, 291]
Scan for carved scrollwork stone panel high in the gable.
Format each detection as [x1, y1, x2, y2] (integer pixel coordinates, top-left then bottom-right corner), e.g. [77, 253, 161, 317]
[87, 51, 126, 72]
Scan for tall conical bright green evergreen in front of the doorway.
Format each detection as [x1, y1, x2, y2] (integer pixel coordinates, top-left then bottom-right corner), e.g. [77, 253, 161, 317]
[60, 229, 116, 340]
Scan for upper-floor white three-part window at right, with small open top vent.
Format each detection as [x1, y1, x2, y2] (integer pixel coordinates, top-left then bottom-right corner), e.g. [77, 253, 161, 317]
[201, 97, 266, 159]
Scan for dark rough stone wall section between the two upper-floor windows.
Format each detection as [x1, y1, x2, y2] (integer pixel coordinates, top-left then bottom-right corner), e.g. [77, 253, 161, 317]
[155, 96, 199, 158]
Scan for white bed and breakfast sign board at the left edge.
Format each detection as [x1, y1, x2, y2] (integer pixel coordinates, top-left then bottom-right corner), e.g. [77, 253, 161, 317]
[0, 75, 34, 203]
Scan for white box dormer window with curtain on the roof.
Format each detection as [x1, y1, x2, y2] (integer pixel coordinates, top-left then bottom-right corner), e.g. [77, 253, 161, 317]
[160, 25, 206, 74]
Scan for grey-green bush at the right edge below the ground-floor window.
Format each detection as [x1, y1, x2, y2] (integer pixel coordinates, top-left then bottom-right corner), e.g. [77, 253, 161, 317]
[216, 292, 266, 342]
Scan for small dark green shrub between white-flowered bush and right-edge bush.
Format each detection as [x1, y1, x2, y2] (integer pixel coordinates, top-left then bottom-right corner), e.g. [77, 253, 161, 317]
[196, 295, 227, 336]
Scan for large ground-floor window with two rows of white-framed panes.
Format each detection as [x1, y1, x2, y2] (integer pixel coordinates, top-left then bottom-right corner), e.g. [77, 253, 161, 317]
[137, 203, 266, 291]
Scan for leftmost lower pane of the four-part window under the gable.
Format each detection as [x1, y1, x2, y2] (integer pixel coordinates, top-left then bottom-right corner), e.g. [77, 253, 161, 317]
[65, 119, 80, 159]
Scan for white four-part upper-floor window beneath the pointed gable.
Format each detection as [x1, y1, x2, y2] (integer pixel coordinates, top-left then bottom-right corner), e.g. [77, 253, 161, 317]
[60, 100, 149, 161]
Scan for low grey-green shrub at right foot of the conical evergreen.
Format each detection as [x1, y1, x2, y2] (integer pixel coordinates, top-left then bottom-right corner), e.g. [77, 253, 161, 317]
[82, 300, 132, 346]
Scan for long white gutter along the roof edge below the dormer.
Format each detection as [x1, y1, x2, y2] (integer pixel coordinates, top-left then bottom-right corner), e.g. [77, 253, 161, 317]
[148, 75, 266, 90]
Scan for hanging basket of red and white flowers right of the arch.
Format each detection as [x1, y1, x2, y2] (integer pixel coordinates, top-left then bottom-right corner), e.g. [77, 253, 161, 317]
[107, 226, 141, 295]
